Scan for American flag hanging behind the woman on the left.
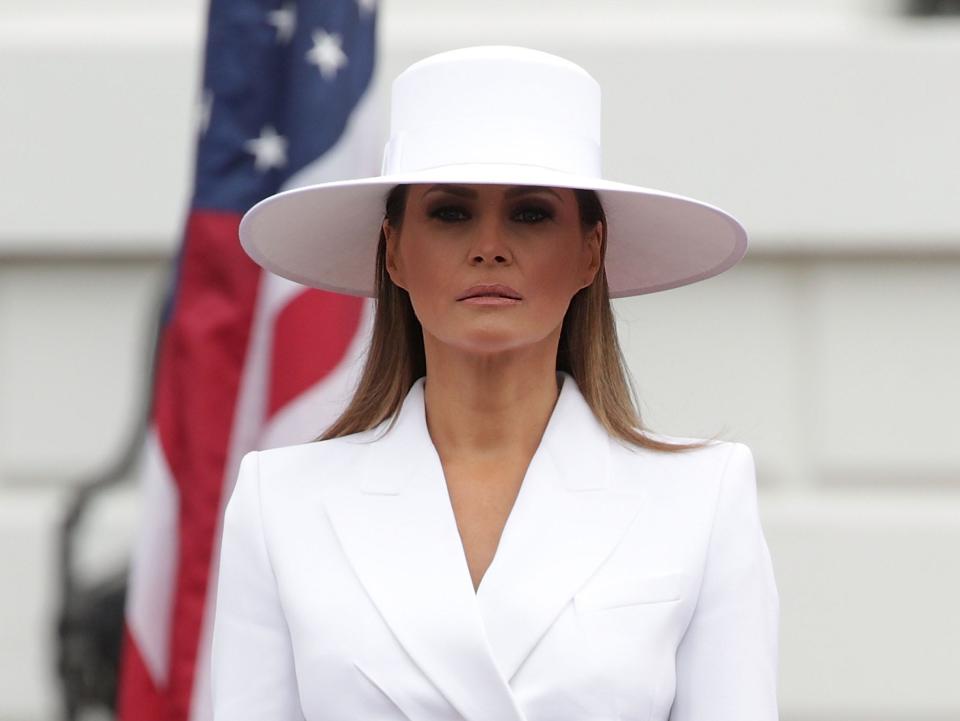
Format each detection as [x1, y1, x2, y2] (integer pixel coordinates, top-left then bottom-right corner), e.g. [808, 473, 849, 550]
[117, 0, 382, 721]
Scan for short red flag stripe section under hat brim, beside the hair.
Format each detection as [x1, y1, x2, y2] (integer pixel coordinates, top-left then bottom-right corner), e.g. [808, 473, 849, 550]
[267, 290, 363, 418]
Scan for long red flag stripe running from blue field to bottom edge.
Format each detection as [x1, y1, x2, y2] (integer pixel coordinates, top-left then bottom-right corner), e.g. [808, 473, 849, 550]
[127, 212, 260, 721]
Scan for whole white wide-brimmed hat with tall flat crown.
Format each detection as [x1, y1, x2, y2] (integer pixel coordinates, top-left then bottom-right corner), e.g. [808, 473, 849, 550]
[240, 46, 747, 298]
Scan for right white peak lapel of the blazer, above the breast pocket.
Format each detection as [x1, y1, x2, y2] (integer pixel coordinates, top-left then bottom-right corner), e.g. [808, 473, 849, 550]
[477, 374, 644, 682]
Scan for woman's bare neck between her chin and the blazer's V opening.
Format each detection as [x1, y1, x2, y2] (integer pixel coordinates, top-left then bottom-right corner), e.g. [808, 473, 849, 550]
[424, 332, 559, 459]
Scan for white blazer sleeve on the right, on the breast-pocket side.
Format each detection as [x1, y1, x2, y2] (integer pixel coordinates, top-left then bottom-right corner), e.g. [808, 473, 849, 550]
[670, 443, 780, 721]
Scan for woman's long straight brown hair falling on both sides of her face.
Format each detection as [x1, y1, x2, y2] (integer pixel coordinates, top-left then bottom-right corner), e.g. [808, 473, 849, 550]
[318, 185, 707, 451]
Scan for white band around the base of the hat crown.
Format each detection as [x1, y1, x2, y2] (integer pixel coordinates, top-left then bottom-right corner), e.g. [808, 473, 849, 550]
[381, 128, 602, 178]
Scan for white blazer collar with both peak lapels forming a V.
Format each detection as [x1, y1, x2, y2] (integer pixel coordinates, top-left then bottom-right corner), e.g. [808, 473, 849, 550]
[326, 373, 643, 721]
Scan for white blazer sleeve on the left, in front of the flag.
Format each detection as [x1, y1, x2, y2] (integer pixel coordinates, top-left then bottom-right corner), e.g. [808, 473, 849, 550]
[210, 452, 303, 721]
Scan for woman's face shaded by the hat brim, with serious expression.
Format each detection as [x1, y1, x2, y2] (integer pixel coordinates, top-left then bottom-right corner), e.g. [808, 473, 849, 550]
[384, 184, 602, 353]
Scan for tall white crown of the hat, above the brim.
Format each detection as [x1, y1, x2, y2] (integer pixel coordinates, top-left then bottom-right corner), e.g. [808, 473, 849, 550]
[382, 46, 601, 178]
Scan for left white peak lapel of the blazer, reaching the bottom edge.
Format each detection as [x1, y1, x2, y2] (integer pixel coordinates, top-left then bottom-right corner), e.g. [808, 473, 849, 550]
[326, 379, 524, 721]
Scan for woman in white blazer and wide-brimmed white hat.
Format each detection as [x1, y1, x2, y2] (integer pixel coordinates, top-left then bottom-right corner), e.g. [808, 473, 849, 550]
[213, 47, 779, 721]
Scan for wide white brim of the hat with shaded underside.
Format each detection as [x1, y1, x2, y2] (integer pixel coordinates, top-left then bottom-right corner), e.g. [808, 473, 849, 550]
[240, 163, 747, 298]
